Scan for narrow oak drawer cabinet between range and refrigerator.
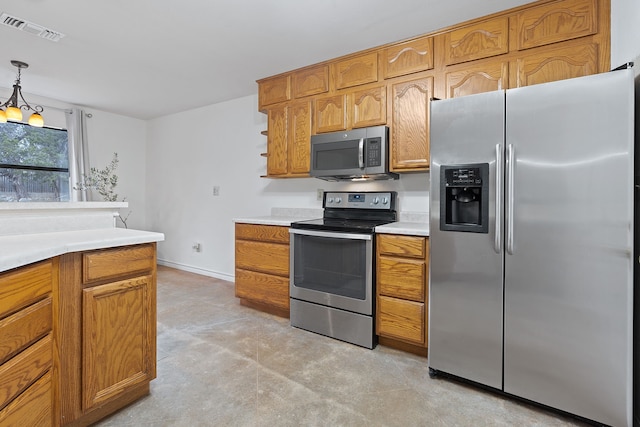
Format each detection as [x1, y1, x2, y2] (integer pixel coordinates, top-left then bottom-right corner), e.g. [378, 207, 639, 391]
[376, 234, 429, 356]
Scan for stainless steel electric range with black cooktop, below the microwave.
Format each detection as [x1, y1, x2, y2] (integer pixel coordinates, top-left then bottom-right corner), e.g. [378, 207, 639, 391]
[290, 191, 397, 349]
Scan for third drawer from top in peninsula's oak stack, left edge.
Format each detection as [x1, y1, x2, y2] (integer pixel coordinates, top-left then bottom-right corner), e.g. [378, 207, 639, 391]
[0, 334, 53, 408]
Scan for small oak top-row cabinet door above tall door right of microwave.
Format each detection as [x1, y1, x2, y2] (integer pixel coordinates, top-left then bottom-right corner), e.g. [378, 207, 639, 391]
[380, 37, 433, 79]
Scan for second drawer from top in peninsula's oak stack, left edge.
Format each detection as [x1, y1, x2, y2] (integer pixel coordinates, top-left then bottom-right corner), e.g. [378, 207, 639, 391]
[0, 298, 53, 363]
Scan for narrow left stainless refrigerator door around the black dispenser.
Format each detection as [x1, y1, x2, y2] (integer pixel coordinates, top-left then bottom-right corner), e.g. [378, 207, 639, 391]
[429, 91, 504, 389]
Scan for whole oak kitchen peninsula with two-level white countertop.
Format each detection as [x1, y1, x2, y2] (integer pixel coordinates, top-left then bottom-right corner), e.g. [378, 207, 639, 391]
[0, 202, 164, 426]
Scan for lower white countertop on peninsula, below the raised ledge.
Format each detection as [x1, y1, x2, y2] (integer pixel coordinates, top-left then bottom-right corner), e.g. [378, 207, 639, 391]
[0, 228, 164, 271]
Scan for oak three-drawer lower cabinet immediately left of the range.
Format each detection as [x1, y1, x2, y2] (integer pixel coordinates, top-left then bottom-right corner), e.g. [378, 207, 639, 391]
[235, 223, 289, 317]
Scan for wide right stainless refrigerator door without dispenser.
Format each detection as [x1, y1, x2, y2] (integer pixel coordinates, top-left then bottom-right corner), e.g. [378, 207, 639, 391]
[504, 70, 634, 426]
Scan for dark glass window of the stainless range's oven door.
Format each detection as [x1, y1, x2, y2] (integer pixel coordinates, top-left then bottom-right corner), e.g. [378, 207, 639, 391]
[292, 235, 372, 300]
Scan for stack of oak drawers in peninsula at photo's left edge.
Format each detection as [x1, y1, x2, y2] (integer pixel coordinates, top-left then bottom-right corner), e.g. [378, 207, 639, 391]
[0, 259, 58, 426]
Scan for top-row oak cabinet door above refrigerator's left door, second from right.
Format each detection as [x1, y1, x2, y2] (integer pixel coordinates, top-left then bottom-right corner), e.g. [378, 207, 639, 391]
[444, 17, 509, 65]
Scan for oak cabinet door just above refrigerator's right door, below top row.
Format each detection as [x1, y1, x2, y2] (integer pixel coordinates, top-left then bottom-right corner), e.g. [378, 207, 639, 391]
[509, 41, 598, 87]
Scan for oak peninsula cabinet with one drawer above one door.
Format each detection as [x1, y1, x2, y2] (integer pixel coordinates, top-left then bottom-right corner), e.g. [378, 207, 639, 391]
[56, 243, 157, 426]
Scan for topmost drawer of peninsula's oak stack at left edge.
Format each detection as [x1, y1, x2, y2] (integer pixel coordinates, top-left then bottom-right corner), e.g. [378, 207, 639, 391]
[0, 260, 53, 318]
